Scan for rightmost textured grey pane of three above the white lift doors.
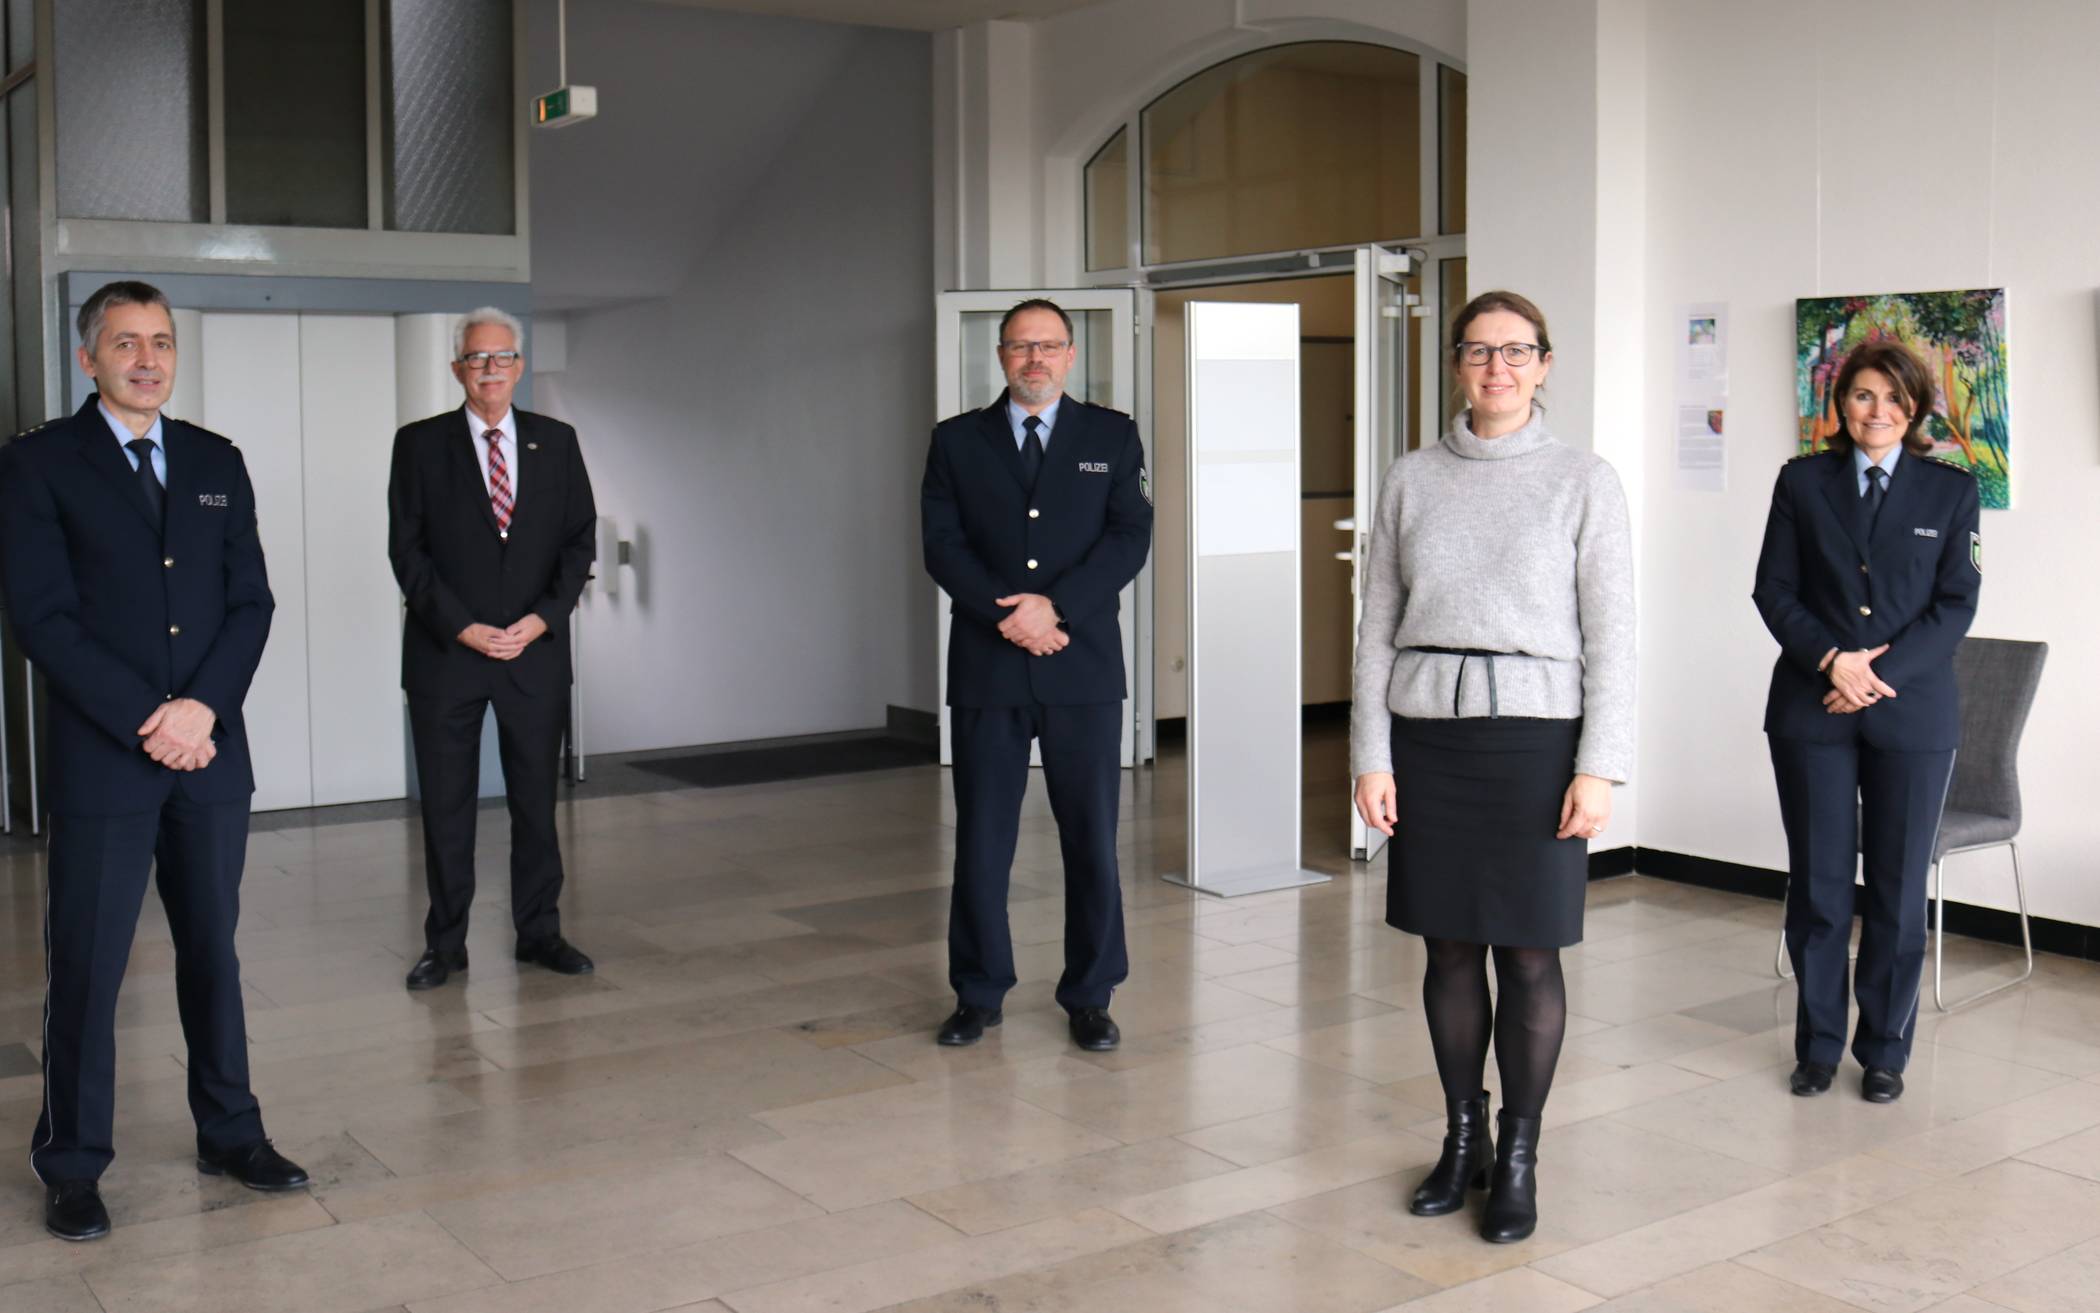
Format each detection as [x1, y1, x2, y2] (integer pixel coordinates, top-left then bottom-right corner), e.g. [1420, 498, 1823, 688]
[386, 0, 521, 233]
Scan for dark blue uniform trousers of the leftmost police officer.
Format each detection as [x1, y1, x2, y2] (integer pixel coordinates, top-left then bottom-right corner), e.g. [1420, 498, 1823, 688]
[29, 790, 263, 1183]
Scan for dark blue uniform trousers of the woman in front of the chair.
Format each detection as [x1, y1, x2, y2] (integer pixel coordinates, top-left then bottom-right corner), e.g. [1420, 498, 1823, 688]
[1770, 735, 1955, 1071]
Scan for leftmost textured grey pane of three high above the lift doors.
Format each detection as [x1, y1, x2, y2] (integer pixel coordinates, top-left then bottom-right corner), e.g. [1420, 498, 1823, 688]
[53, 0, 210, 223]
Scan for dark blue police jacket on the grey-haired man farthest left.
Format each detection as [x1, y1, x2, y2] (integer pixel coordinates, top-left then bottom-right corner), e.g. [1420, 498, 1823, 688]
[0, 397, 275, 815]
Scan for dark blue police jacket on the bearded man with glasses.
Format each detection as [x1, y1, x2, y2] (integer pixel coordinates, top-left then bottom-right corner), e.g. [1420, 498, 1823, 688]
[920, 393, 1153, 706]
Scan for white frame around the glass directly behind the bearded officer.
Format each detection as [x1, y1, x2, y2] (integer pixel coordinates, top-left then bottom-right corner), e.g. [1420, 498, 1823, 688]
[932, 288, 1153, 767]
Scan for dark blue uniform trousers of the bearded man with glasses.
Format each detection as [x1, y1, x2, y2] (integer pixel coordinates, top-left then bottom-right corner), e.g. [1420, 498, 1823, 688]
[947, 701, 1130, 1013]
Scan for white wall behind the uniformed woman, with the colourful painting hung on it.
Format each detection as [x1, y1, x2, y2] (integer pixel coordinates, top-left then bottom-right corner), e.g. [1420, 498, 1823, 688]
[1640, 0, 2100, 924]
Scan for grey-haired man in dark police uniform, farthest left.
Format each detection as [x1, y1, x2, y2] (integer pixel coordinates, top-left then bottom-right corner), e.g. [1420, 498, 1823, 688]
[0, 282, 307, 1239]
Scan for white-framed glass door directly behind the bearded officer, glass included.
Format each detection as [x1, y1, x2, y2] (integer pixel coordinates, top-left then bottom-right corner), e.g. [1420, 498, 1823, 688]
[935, 288, 1151, 767]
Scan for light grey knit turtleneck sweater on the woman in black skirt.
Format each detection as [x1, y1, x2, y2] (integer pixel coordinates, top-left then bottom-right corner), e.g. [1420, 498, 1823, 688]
[1350, 408, 1634, 781]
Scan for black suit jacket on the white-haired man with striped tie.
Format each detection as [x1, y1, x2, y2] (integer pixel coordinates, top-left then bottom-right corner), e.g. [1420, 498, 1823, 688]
[386, 405, 599, 693]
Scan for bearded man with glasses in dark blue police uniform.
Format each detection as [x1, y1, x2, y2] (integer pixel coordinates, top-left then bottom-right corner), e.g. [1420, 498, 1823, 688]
[920, 300, 1153, 1053]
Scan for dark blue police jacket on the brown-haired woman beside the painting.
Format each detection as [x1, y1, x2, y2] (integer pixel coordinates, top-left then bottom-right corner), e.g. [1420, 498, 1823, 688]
[1751, 452, 1982, 752]
